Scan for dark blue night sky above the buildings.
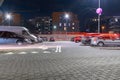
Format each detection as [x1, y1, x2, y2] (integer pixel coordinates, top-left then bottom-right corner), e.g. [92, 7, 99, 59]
[1, 0, 120, 18]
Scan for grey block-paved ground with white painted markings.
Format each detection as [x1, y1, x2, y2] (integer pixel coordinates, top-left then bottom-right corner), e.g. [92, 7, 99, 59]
[0, 41, 120, 80]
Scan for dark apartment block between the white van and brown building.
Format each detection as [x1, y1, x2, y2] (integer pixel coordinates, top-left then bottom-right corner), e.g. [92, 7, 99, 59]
[29, 17, 52, 34]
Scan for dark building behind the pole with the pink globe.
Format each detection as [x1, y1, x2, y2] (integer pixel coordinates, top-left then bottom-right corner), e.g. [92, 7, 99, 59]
[85, 16, 112, 33]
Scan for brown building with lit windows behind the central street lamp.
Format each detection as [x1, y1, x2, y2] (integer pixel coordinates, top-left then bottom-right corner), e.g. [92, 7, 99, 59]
[52, 12, 79, 33]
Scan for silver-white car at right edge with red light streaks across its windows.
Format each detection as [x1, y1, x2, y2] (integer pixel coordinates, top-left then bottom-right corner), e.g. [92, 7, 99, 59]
[91, 34, 120, 47]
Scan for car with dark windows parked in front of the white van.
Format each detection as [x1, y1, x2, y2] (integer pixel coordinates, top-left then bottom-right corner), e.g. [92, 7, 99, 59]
[0, 31, 32, 45]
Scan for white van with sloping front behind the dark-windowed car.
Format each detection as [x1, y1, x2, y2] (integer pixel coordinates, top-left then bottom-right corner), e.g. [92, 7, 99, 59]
[0, 26, 38, 42]
